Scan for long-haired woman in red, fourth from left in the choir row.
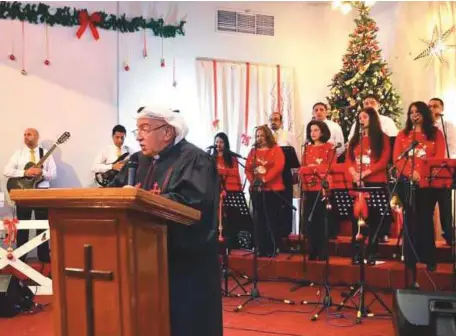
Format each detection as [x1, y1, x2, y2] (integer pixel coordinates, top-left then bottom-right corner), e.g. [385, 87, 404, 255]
[346, 107, 391, 265]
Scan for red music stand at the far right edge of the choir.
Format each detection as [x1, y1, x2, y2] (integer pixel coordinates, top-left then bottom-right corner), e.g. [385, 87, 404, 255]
[419, 159, 456, 291]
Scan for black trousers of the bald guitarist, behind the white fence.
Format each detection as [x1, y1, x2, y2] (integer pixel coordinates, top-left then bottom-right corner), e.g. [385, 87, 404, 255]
[16, 207, 51, 262]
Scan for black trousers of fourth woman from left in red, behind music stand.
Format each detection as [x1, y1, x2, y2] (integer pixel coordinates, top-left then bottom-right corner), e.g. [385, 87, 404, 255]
[351, 182, 391, 256]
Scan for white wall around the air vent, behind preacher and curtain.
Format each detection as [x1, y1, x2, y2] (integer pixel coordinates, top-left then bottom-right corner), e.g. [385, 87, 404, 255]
[119, 2, 351, 147]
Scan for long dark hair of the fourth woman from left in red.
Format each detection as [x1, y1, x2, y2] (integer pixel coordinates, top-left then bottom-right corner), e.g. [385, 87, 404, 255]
[348, 107, 384, 160]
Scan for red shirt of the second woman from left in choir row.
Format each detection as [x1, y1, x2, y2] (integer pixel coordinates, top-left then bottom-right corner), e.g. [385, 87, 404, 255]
[245, 145, 285, 191]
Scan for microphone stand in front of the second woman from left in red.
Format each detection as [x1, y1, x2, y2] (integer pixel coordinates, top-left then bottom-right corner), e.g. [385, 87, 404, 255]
[234, 143, 294, 312]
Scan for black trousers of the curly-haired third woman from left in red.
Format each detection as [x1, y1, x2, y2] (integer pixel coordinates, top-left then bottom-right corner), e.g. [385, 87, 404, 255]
[301, 191, 332, 259]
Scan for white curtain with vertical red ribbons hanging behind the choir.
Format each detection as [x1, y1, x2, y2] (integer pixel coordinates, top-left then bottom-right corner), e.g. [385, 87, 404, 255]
[197, 60, 295, 155]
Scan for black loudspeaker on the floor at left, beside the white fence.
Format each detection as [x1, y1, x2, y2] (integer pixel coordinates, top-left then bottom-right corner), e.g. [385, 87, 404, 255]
[0, 275, 35, 317]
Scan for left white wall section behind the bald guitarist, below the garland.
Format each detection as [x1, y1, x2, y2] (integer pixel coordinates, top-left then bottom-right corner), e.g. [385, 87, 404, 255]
[0, 2, 118, 210]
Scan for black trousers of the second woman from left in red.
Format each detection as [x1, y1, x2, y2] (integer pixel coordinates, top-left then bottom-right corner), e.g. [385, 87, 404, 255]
[251, 191, 283, 256]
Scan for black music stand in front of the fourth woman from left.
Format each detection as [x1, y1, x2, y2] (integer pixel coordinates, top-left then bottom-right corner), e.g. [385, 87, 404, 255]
[336, 187, 392, 324]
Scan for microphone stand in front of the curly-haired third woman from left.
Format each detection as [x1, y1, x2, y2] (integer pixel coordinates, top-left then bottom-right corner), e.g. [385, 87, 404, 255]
[301, 146, 337, 321]
